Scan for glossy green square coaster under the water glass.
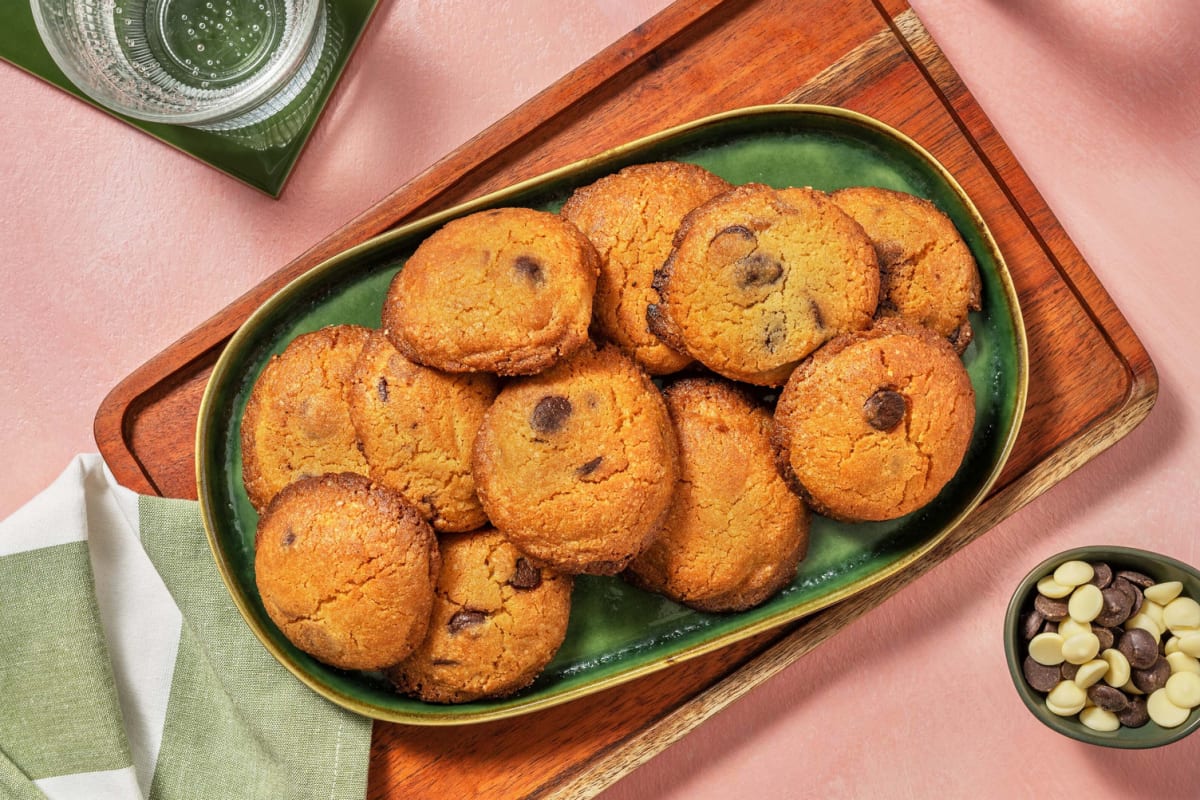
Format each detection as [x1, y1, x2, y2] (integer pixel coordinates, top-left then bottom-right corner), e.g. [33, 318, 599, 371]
[0, 0, 378, 197]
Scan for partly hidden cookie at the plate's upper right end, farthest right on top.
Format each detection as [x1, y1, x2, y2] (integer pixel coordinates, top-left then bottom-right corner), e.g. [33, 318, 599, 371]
[832, 186, 979, 353]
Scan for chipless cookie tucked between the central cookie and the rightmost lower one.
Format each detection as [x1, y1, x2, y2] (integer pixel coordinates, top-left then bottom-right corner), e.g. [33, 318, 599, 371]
[626, 378, 809, 612]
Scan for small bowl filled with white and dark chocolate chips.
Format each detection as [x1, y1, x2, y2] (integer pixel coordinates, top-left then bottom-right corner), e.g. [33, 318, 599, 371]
[1004, 546, 1200, 750]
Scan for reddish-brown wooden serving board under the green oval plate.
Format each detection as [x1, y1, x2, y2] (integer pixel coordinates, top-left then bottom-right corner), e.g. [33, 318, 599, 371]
[96, 0, 1158, 799]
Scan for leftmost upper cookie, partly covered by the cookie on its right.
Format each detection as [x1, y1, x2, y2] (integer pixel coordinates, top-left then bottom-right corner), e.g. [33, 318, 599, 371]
[241, 325, 370, 511]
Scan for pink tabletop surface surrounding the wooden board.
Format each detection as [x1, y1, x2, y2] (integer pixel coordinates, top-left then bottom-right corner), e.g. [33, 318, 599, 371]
[0, 0, 1200, 800]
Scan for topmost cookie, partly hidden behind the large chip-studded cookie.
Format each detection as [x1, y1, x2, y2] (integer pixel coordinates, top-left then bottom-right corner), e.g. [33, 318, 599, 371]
[562, 162, 732, 375]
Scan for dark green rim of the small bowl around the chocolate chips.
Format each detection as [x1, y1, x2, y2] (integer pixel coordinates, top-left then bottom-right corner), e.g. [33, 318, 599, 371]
[1003, 545, 1200, 750]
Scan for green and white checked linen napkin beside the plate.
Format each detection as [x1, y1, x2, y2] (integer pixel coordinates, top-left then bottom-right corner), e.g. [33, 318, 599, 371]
[0, 455, 371, 800]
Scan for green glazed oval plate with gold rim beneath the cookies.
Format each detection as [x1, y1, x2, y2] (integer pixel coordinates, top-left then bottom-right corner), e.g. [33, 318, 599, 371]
[196, 106, 1027, 724]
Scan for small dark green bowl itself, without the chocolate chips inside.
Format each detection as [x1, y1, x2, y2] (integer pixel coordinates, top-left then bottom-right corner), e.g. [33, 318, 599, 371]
[1004, 546, 1200, 750]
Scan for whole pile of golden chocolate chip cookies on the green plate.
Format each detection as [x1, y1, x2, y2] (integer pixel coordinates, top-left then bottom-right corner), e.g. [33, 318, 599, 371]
[241, 162, 979, 702]
